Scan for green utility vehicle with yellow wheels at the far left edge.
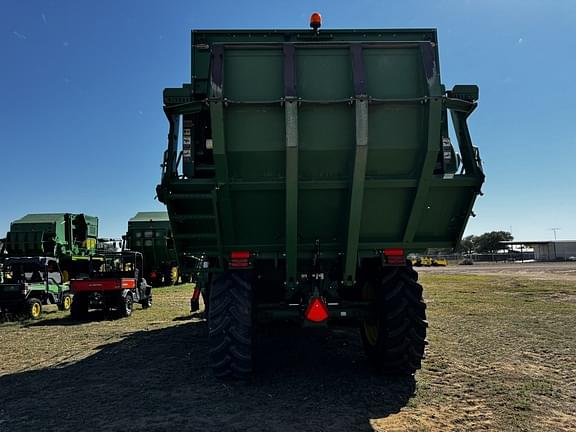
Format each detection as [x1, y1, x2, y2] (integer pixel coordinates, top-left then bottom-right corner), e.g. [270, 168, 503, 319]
[0, 257, 72, 319]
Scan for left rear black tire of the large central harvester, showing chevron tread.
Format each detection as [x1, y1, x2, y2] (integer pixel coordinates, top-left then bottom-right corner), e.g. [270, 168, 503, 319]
[208, 271, 252, 379]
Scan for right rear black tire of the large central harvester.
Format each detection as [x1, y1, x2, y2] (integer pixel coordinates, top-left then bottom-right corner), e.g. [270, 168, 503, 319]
[360, 267, 428, 375]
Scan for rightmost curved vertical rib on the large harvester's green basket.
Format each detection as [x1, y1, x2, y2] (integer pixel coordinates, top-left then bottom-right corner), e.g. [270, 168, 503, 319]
[402, 42, 442, 243]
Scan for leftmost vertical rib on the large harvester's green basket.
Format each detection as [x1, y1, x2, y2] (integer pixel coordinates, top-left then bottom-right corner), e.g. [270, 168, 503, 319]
[210, 45, 234, 243]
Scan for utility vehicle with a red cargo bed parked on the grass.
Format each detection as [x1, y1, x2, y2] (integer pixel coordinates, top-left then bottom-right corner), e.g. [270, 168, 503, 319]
[70, 251, 152, 319]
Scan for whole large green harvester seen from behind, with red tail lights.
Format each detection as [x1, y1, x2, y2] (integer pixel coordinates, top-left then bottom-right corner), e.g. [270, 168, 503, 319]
[157, 24, 484, 377]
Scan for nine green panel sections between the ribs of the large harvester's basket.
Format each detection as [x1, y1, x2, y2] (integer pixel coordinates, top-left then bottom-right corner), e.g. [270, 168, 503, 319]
[220, 45, 430, 250]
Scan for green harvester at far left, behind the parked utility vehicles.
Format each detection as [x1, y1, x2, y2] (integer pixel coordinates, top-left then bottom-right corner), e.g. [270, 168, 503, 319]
[3, 213, 98, 280]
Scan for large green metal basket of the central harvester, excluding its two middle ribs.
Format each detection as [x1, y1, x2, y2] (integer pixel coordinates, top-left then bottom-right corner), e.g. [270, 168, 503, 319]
[159, 30, 483, 264]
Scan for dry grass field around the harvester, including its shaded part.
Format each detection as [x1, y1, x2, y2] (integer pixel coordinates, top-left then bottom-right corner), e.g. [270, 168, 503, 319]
[0, 264, 576, 432]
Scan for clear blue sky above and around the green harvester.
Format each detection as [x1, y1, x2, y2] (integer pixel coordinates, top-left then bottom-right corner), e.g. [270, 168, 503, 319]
[0, 0, 576, 240]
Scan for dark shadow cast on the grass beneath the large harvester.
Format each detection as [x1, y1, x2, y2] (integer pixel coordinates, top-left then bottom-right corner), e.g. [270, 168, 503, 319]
[0, 321, 415, 432]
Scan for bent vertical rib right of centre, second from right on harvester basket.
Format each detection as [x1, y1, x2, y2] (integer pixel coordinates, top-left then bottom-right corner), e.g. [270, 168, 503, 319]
[344, 44, 368, 285]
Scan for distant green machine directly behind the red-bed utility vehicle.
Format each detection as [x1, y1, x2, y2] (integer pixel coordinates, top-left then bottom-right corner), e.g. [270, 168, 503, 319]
[126, 212, 180, 286]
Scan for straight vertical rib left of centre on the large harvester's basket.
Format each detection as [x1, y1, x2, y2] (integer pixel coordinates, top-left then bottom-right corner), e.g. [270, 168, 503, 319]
[283, 44, 298, 286]
